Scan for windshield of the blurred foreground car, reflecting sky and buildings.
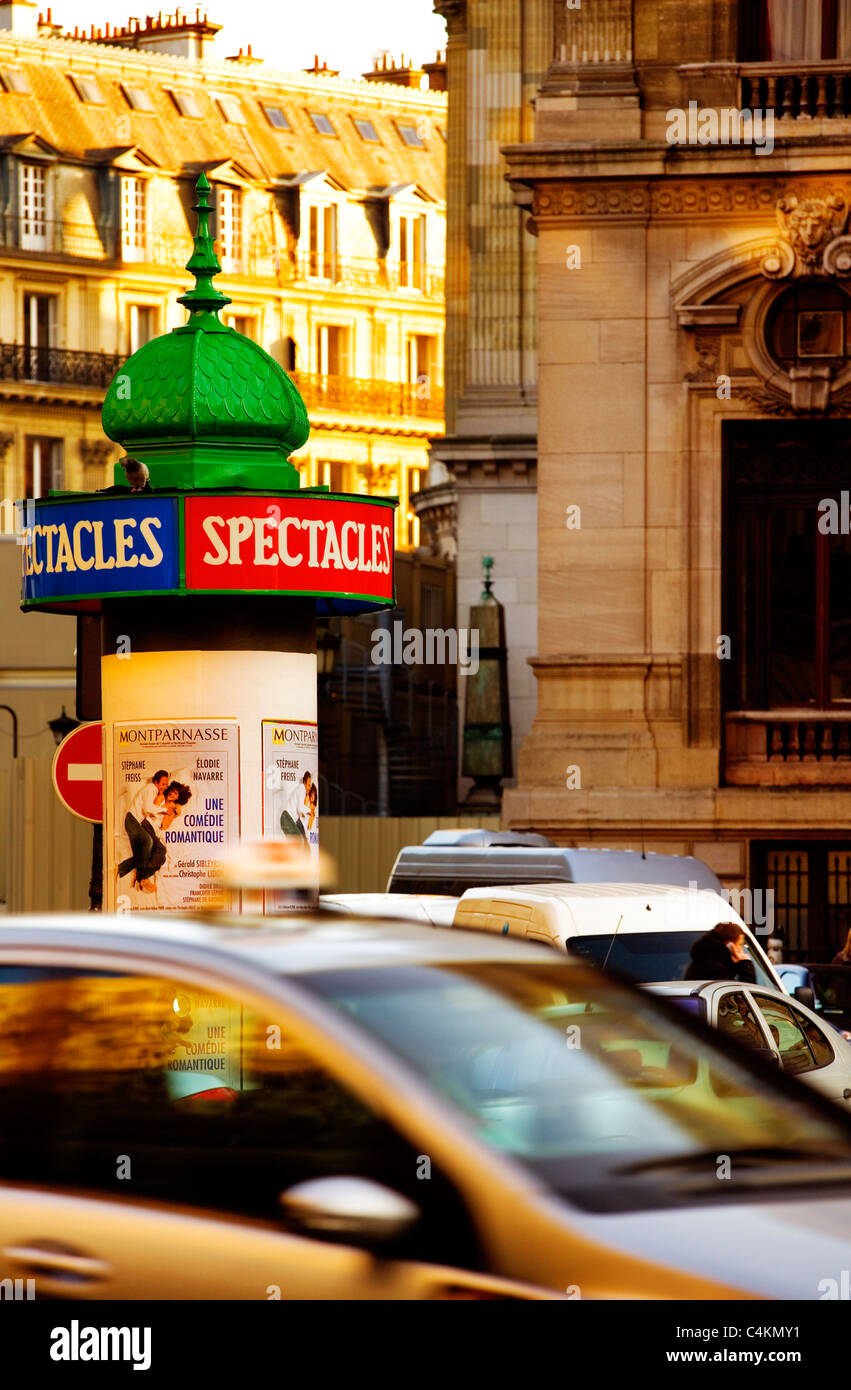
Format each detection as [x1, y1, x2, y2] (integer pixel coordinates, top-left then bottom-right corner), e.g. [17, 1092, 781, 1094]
[300, 959, 851, 1207]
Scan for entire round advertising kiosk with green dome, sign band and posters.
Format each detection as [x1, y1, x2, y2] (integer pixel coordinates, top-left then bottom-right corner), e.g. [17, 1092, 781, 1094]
[16, 174, 396, 912]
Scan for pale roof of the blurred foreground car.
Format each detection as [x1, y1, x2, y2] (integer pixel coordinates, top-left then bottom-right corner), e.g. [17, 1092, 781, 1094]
[0, 912, 558, 976]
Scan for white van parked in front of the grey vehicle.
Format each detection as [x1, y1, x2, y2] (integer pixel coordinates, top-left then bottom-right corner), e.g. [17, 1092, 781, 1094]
[452, 883, 788, 992]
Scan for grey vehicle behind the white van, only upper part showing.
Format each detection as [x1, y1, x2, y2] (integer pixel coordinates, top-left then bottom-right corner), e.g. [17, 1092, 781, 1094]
[387, 830, 729, 902]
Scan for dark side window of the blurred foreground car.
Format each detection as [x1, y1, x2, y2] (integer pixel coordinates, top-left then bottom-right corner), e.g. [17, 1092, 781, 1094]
[0, 966, 483, 1268]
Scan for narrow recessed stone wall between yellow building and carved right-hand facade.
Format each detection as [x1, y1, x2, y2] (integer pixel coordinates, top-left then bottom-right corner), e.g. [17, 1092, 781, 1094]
[414, 0, 552, 796]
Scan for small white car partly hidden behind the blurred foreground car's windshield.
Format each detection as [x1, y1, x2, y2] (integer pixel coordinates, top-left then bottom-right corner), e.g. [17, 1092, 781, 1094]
[647, 980, 851, 1109]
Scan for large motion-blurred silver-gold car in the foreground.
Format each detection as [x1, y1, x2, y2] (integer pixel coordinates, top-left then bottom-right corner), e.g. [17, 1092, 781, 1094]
[0, 913, 851, 1301]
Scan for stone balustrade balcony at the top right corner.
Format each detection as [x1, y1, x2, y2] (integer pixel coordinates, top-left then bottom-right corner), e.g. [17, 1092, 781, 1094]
[738, 58, 851, 121]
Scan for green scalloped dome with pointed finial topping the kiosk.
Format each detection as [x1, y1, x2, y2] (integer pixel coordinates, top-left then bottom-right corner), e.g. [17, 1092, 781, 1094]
[103, 174, 310, 488]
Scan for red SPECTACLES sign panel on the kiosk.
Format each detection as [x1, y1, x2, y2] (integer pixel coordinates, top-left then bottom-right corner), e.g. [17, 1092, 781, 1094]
[185, 496, 394, 603]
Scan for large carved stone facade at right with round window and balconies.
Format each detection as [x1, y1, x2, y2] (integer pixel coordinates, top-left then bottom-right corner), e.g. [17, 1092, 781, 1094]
[495, 0, 851, 958]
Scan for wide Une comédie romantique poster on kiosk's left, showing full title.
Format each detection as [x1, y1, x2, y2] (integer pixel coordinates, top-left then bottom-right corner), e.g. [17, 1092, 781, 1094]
[111, 719, 239, 912]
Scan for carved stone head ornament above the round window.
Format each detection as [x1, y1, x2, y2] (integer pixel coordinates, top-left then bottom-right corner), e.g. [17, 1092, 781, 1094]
[759, 193, 851, 279]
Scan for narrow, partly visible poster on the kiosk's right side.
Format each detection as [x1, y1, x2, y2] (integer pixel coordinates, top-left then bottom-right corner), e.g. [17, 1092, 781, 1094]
[263, 719, 318, 912]
